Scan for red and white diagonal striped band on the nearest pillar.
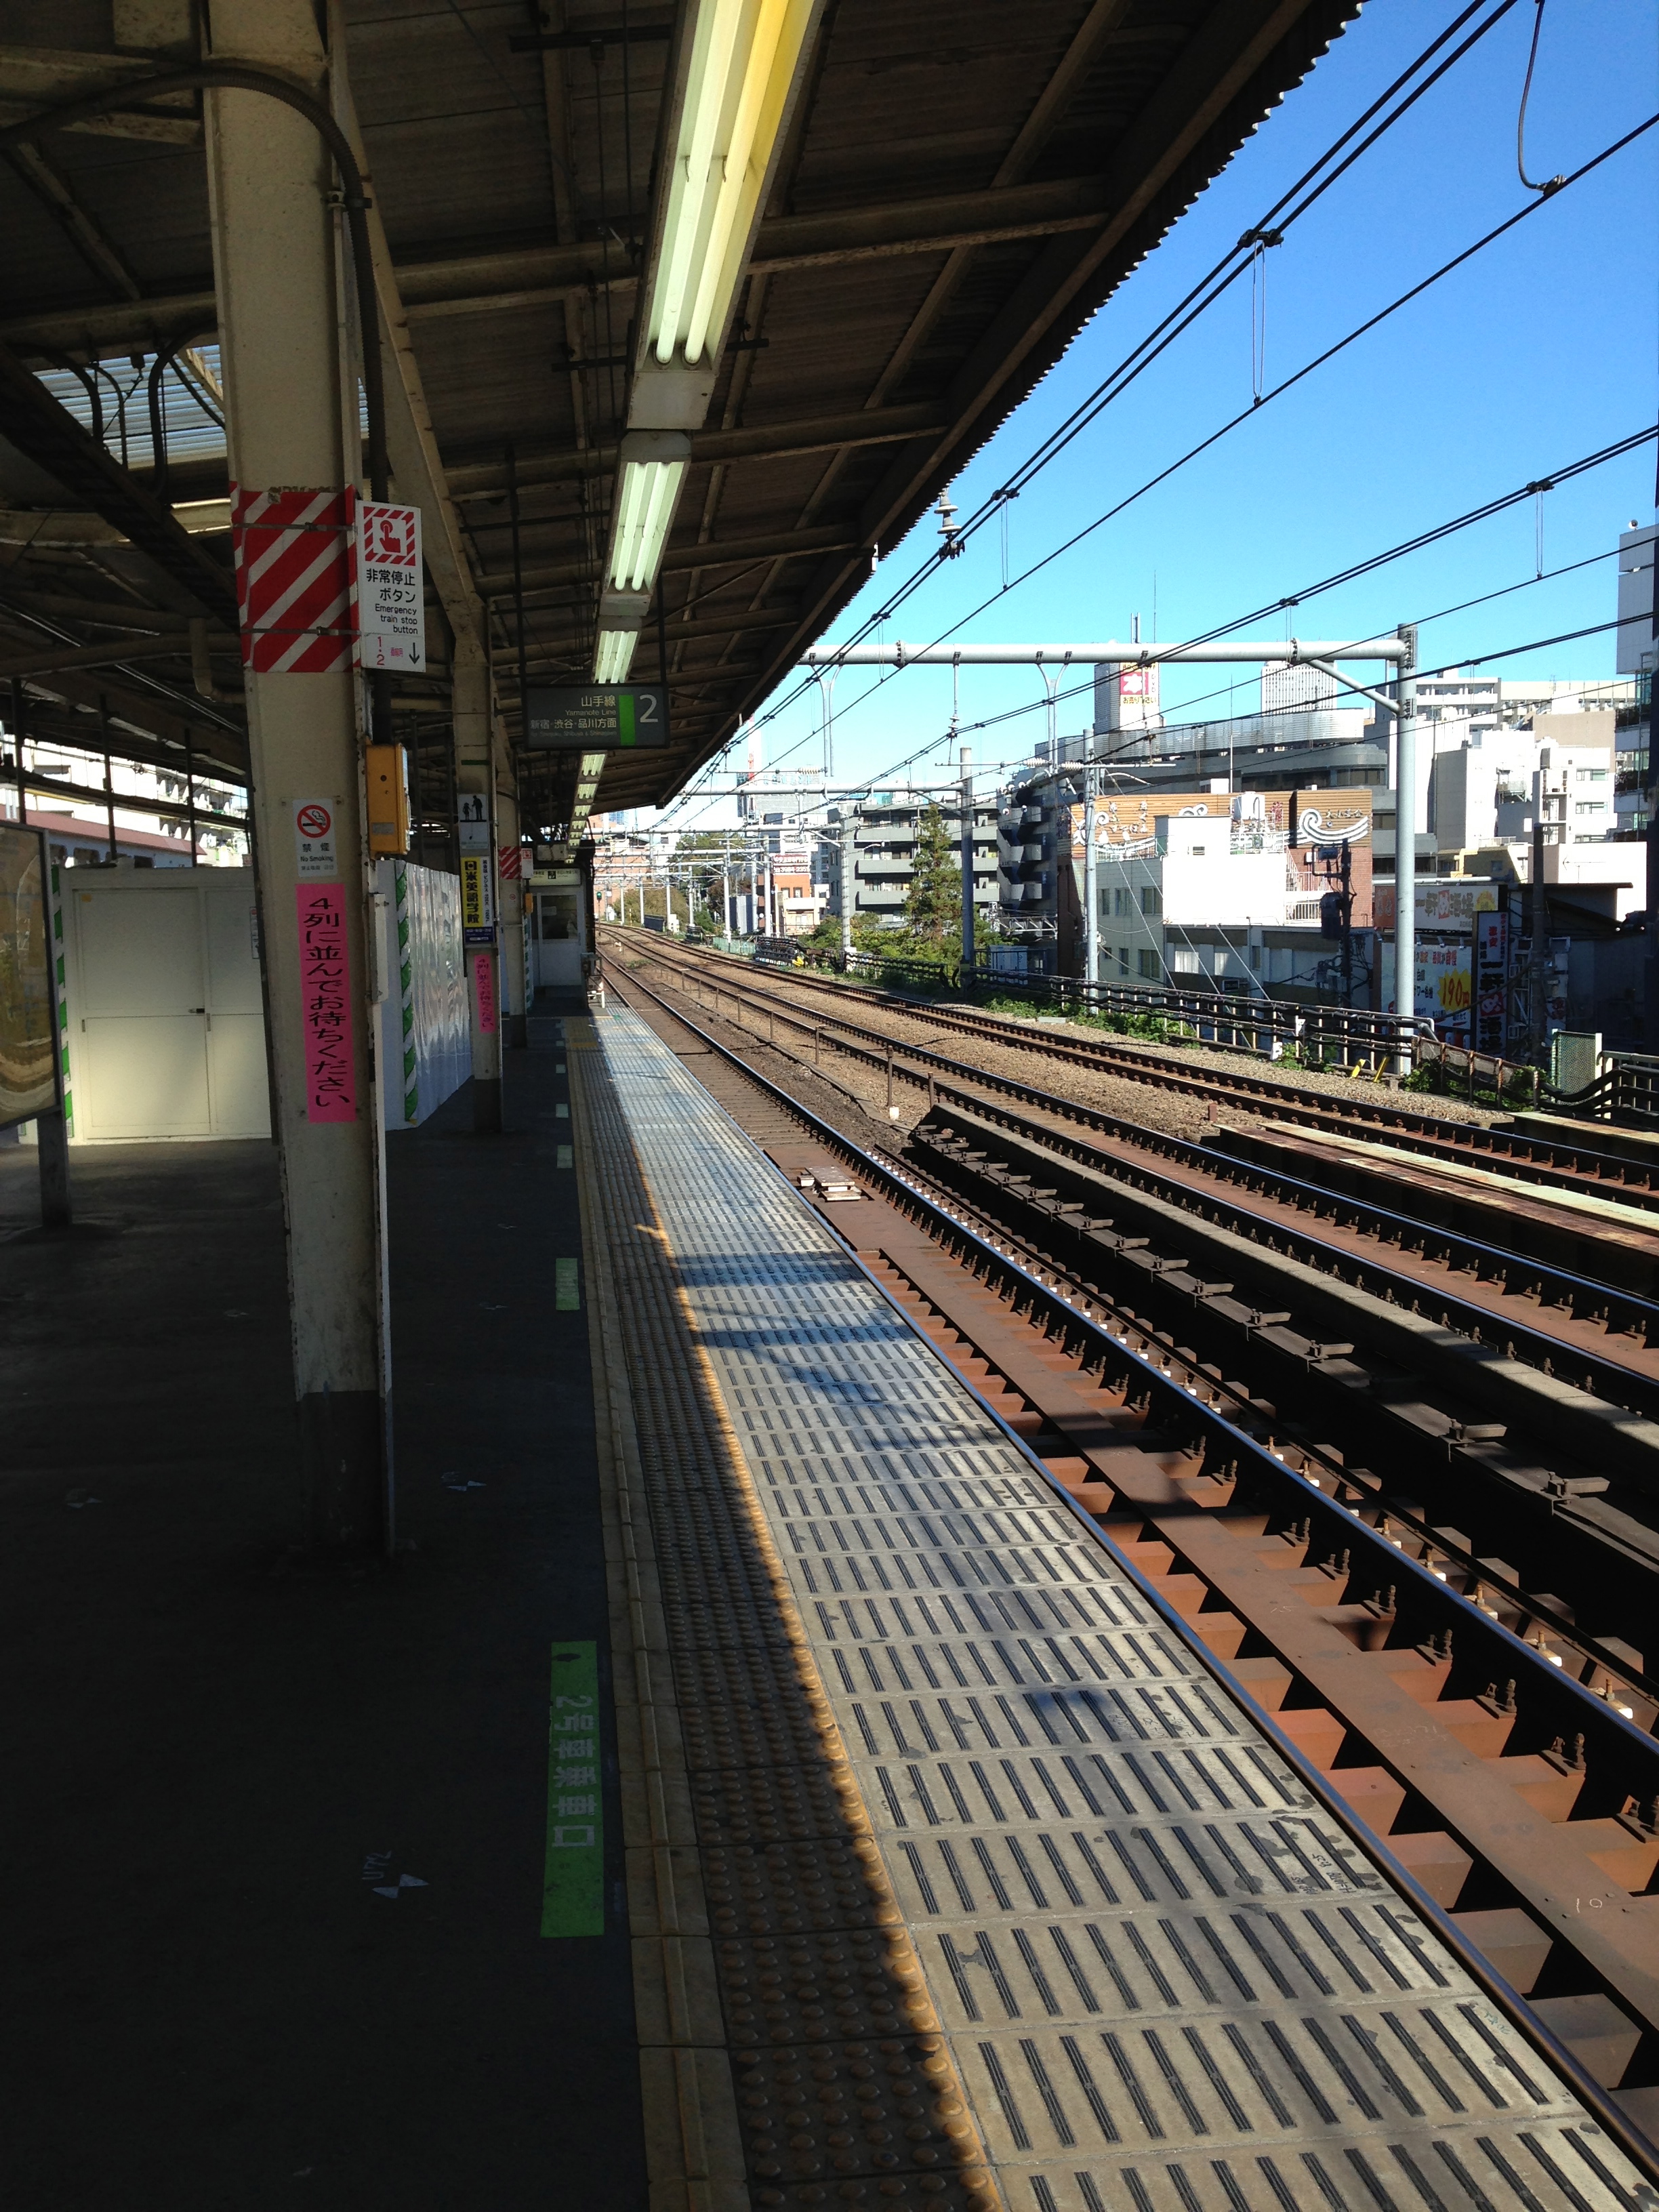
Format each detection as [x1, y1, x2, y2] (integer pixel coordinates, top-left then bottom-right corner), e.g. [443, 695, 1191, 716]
[230, 485, 354, 677]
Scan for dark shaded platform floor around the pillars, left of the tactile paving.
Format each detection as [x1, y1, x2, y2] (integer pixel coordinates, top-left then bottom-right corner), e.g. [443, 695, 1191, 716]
[0, 1022, 644, 2212]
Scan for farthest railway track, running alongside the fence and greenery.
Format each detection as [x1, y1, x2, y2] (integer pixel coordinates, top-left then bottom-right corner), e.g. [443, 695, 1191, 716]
[606, 929, 1659, 1212]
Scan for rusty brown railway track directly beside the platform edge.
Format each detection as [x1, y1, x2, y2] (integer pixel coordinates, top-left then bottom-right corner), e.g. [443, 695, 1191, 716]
[606, 975, 1659, 2123]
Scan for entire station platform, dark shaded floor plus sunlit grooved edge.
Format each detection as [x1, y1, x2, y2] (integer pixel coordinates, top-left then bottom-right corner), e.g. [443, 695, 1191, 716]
[0, 1006, 1650, 2212]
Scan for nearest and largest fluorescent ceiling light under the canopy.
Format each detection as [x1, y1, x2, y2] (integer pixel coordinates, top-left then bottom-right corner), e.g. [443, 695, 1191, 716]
[646, 0, 814, 363]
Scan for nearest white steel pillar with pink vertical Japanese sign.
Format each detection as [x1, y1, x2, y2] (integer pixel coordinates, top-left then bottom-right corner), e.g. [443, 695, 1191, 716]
[206, 0, 394, 1551]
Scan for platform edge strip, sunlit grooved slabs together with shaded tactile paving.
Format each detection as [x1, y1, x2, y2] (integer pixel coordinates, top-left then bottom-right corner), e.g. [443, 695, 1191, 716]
[571, 1008, 1645, 2212]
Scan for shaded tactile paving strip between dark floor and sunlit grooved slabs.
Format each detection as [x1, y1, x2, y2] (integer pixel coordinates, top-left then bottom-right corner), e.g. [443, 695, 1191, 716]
[567, 1015, 1000, 2212]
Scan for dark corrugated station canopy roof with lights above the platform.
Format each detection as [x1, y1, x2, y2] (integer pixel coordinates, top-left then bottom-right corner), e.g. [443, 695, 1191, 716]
[0, 0, 1358, 834]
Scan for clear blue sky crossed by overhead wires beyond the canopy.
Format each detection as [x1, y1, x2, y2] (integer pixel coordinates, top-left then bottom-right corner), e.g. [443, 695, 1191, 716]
[655, 0, 1659, 821]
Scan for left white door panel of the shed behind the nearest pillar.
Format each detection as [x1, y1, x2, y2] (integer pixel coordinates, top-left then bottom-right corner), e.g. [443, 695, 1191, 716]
[70, 876, 212, 1137]
